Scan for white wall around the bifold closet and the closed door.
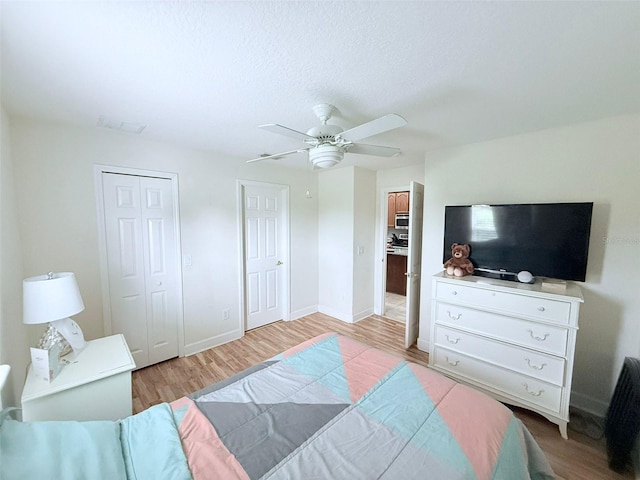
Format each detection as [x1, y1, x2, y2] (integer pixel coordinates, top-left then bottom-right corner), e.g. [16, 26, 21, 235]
[11, 119, 318, 353]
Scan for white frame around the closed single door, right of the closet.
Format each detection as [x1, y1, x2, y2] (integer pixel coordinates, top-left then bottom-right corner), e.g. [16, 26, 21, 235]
[236, 179, 291, 334]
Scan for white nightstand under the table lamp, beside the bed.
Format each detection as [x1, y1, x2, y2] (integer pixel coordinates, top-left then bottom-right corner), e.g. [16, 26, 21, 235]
[22, 334, 136, 421]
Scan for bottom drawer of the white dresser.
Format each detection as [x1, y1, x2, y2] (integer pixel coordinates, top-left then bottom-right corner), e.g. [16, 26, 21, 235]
[432, 346, 562, 413]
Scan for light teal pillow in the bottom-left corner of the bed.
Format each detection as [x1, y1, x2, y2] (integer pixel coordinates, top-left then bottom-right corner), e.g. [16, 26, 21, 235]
[0, 412, 127, 480]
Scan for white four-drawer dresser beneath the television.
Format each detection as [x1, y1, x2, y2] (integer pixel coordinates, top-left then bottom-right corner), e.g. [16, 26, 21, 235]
[429, 272, 583, 438]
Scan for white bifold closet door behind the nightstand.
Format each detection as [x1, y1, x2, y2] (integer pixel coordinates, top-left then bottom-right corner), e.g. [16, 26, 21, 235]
[102, 173, 178, 368]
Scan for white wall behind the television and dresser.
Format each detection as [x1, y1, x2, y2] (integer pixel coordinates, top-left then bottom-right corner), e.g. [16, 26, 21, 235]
[420, 115, 640, 415]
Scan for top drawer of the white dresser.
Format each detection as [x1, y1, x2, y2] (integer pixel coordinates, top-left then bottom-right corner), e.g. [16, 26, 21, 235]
[436, 282, 571, 325]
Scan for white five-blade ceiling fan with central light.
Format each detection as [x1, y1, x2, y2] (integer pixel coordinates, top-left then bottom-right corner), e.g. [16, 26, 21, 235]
[247, 103, 407, 168]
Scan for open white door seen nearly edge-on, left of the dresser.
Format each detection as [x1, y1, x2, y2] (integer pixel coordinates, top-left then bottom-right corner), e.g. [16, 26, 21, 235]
[404, 182, 424, 348]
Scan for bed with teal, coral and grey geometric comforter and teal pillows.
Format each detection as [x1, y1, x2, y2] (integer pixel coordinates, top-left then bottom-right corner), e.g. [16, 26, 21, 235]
[0, 333, 554, 480]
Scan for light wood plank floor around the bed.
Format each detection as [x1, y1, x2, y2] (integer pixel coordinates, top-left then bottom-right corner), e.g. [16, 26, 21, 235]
[133, 313, 634, 480]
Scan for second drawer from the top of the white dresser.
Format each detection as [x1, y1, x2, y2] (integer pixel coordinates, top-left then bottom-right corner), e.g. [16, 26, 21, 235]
[435, 302, 568, 357]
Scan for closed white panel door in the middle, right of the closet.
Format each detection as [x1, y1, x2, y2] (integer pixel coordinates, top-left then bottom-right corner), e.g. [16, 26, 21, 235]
[244, 185, 287, 330]
